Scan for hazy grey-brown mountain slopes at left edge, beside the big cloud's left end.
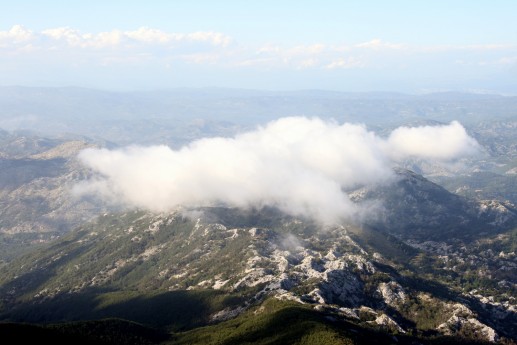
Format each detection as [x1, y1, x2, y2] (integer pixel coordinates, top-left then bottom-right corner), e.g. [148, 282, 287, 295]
[0, 132, 102, 260]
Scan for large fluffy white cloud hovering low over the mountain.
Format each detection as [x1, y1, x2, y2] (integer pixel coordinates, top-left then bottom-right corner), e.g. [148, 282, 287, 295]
[75, 117, 479, 223]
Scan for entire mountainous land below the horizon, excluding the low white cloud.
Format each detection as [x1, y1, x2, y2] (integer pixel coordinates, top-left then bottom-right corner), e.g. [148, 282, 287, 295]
[0, 87, 517, 344]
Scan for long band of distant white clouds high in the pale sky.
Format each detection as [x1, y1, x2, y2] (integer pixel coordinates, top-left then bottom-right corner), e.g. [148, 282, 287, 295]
[0, 25, 517, 71]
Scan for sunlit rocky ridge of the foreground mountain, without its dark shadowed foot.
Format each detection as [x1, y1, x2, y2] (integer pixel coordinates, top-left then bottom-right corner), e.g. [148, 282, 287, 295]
[0, 204, 516, 342]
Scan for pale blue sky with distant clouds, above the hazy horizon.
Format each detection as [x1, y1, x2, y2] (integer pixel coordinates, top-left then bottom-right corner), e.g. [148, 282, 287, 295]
[0, 0, 517, 95]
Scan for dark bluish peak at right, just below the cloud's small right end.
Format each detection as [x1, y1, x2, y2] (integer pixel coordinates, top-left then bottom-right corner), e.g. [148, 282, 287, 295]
[350, 168, 517, 241]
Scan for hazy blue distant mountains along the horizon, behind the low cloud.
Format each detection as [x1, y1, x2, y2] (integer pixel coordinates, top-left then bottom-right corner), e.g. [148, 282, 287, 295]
[0, 86, 517, 146]
